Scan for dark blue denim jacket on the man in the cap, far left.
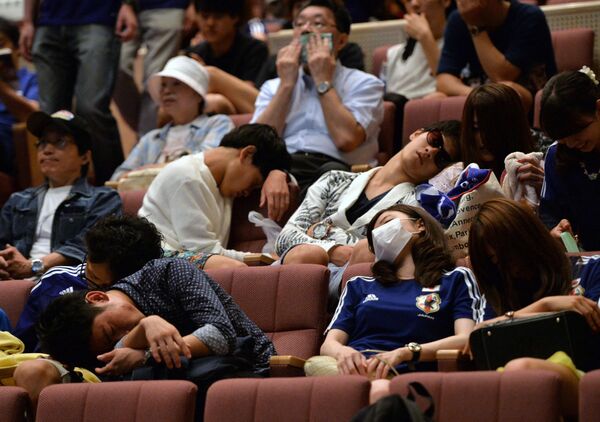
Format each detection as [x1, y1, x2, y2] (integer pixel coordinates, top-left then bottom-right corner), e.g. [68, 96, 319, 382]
[0, 178, 121, 261]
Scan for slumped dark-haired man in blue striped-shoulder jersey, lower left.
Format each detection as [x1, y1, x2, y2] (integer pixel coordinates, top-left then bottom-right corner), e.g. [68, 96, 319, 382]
[13, 215, 162, 352]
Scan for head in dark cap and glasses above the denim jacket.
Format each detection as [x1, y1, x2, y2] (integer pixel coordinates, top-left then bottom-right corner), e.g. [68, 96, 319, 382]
[27, 110, 92, 188]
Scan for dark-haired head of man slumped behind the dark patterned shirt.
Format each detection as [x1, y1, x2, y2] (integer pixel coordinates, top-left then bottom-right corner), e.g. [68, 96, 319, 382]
[85, 215, 162, 288]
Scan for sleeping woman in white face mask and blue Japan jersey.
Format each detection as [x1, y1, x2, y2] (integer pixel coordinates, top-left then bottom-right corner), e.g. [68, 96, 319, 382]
[305, 205, 485, 379]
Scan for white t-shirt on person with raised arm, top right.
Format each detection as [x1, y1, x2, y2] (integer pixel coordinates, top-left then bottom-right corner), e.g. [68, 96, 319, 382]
[385, 38, 444, 100]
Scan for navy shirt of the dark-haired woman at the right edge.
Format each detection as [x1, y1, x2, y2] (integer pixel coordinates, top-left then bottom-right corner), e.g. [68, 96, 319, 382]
[540, 144, 600, 251]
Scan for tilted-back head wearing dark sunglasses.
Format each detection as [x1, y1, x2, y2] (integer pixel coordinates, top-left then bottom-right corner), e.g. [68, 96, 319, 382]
[392, 120, 460, 185]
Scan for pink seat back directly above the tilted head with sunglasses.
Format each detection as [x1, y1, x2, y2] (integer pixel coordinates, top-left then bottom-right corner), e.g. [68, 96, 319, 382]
[402, 97, 467, 145]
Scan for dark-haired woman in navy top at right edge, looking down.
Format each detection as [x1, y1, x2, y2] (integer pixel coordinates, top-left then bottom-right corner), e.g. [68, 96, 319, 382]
[540, 68, 600, 251]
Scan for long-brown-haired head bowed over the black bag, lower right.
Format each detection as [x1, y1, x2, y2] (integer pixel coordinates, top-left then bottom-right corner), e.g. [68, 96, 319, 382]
[469, 198, 571, 315]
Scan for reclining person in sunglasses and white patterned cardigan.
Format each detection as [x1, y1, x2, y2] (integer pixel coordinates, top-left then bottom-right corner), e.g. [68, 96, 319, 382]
[275, 120, 460, 297]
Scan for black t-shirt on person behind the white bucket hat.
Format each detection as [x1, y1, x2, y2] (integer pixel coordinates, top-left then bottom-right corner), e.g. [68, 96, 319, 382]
[188, 33, 269, 84]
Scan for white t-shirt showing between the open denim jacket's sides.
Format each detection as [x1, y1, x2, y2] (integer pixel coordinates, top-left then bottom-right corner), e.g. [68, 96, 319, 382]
[29, 185, 73, 259]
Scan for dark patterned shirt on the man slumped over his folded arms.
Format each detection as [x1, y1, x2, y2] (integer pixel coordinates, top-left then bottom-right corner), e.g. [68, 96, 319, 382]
[112, 258, 275, 369]
